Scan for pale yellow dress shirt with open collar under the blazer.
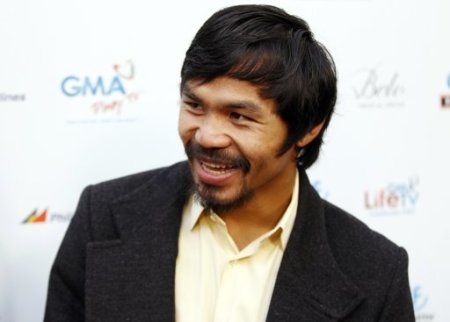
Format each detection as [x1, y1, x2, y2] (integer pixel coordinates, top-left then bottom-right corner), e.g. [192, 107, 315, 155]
[175, 173, 299, 322]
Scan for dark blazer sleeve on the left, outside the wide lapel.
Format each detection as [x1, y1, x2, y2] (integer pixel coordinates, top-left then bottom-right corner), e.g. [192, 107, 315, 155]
[44, 187, 91, 322]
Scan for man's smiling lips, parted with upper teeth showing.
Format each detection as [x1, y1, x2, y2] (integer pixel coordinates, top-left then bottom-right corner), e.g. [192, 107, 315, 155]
[193, 159, 240, 186]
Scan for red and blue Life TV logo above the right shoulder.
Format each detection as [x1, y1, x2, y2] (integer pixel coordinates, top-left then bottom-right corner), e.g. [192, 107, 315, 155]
[364, 176, 420, 215]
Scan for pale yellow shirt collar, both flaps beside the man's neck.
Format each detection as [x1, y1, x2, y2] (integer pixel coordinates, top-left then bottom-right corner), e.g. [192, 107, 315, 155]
[185, 171, 299, 250]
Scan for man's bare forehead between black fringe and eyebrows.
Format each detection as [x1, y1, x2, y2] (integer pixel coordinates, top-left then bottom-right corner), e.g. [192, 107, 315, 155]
[181, 76, 276, 112]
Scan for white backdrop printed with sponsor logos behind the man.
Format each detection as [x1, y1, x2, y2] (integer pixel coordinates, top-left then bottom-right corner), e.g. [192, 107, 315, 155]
[0, 0, 450, 322]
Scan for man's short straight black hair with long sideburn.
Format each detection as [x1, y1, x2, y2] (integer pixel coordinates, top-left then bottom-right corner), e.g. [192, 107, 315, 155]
[181, 5, 337, 168]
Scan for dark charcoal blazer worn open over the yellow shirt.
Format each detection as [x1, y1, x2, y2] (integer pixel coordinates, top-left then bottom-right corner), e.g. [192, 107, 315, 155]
[44, 162, 414, 322]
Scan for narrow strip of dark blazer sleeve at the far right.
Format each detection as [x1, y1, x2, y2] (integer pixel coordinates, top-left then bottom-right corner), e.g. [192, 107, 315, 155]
[379, 248, 415, 322]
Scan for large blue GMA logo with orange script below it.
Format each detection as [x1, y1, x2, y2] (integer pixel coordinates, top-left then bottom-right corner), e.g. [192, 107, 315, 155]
[61, 60, 140, 121]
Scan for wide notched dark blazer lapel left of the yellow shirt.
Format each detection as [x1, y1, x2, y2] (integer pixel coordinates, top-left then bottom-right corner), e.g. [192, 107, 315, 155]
[86, 165, 190, 321]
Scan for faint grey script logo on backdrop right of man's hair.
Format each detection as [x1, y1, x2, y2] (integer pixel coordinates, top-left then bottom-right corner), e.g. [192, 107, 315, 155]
[352, 66, 406, 108]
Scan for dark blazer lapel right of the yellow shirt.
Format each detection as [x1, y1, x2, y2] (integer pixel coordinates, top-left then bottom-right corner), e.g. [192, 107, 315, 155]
[267, 170, 363, 322]
